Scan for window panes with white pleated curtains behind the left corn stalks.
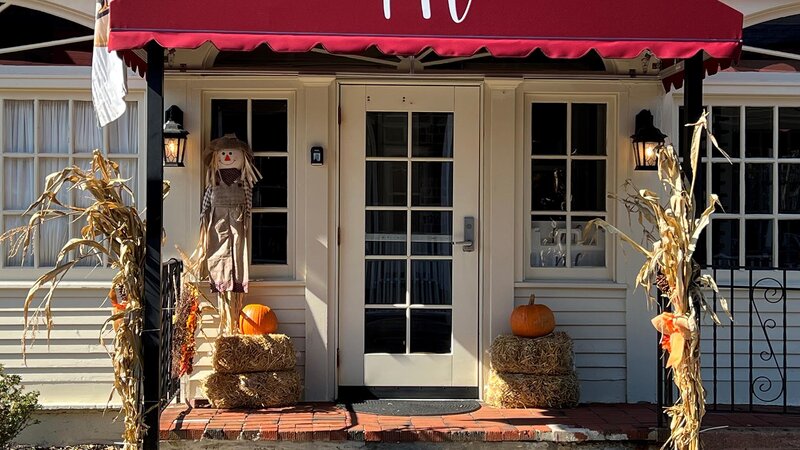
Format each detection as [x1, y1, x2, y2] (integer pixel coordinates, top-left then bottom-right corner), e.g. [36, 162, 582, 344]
[0, 94, 142, 270]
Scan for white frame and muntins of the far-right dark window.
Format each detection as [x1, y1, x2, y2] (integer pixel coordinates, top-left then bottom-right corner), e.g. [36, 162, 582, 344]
[672, 101, 800, 270]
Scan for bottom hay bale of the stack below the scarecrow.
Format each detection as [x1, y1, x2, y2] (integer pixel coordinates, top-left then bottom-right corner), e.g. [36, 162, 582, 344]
[203, 370, 301, 408]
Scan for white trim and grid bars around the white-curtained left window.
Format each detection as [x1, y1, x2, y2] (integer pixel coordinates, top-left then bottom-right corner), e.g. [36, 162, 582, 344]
[0, 91, 147, 282]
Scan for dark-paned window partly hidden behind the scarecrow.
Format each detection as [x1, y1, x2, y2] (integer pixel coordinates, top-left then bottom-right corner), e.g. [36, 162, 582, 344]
[209, 95, 294, 279]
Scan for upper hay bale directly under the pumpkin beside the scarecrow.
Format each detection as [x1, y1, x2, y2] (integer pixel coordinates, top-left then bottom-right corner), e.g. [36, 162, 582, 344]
[211, 334, 297, 373]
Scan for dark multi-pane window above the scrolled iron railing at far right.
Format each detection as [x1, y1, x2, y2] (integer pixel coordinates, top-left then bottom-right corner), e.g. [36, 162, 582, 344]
[678, 103, 800, 268]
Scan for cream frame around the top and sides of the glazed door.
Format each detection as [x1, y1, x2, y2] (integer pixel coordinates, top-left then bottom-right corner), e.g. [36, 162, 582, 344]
[328, 77, 487, 399]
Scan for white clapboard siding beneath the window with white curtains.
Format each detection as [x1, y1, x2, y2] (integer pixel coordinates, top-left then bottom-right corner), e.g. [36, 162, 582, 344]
[0, 286, 115, 407]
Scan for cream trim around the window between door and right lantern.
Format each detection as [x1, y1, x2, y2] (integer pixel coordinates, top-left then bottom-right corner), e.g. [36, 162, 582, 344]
[517, 92, 619, 281]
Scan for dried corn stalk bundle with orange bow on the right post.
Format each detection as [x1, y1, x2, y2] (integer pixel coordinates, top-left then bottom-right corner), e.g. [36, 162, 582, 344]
[587, 112, 727, 450]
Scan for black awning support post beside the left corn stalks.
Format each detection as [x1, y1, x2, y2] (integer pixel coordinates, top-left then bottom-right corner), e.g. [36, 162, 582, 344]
[142, 42, 164, 450]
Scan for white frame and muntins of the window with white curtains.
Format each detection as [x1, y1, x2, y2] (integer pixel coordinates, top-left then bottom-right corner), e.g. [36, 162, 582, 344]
[0, 88, 147, 281]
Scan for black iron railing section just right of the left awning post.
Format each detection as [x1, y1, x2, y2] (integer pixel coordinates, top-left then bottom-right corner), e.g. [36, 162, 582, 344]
[159, 258, 183, 408]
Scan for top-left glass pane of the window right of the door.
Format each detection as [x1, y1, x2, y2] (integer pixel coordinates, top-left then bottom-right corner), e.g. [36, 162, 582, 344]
[531, 103, 567, 155]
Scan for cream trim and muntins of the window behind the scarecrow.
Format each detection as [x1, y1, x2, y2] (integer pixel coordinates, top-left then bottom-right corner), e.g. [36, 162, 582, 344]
[200, 90, 297, 284]
